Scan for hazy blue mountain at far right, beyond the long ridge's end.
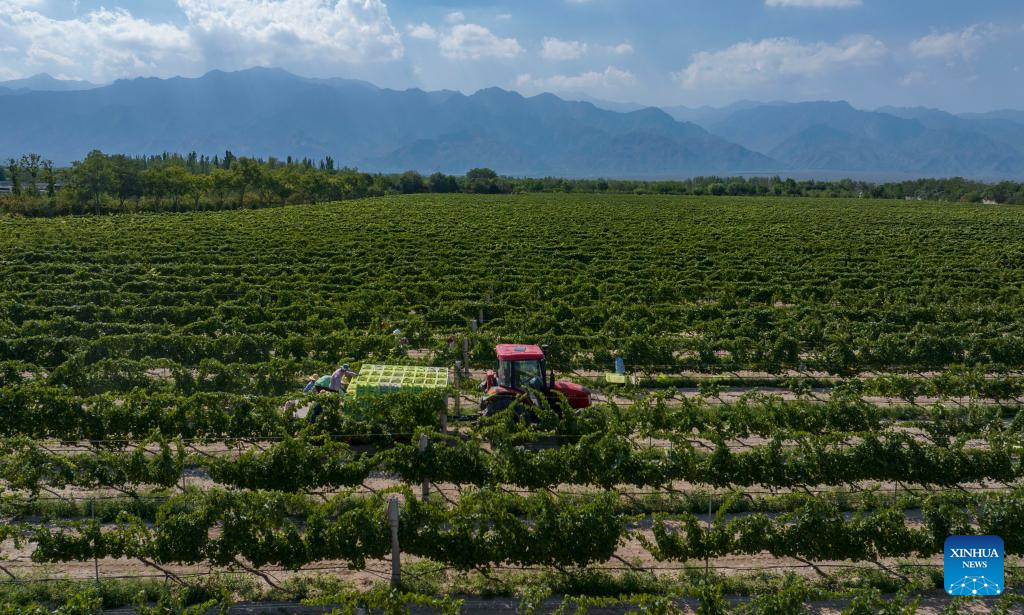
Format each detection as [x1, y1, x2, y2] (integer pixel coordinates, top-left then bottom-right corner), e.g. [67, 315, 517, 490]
[709, 102, 1024, 178]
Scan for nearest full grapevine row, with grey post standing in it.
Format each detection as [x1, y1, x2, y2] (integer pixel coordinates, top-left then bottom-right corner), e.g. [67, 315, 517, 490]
[12, 489, 1024, 570]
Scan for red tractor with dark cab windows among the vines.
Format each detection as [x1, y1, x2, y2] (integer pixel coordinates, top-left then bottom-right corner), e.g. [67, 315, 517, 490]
[480, 344, 591, 416]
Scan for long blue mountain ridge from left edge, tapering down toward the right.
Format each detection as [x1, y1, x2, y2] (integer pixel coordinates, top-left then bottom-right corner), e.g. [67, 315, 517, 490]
[0, 69, 780, 177]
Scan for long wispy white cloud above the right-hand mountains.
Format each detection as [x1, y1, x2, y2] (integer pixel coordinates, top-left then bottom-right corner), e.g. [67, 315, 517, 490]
[673, 35, 888, 88]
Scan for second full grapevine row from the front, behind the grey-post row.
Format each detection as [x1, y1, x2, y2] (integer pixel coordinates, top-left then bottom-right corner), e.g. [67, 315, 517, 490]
[0, 432, 1024, 491]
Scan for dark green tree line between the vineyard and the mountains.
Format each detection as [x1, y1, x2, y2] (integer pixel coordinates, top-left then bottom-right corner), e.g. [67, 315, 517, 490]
[0, 150, 1024, 216]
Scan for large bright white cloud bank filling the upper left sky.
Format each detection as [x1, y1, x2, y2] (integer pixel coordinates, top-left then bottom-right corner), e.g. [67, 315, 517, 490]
[0, 0, 403, 81]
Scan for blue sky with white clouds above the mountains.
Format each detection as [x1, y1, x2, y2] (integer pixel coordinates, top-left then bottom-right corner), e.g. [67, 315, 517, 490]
[0, 0, 1024, 112]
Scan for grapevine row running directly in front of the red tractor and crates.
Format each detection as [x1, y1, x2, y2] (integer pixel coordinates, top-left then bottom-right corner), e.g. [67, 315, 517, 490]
[0, 384, 1024, 441]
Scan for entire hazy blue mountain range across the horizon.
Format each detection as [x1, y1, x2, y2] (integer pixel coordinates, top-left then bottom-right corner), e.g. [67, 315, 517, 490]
[0, 69, 1024, 179]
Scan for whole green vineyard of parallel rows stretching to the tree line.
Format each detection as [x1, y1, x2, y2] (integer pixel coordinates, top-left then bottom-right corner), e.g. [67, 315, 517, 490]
[0, 194, 1024, 613]
